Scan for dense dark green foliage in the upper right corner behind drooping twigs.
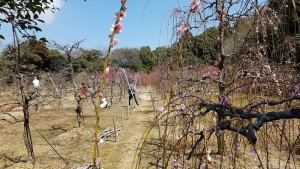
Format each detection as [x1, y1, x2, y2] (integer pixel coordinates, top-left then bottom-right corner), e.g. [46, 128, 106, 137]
[259, 0, 300, 65]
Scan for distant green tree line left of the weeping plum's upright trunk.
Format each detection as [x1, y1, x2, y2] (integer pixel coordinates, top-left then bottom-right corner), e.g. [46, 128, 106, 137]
[0, 28, 216, 76]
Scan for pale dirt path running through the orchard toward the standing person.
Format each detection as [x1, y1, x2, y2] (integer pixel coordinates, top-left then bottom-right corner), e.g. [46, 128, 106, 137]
[104, 88, 161, 169]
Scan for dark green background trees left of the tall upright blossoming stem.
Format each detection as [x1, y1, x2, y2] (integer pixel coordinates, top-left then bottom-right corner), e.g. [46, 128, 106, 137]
[0, 38, 104, 74]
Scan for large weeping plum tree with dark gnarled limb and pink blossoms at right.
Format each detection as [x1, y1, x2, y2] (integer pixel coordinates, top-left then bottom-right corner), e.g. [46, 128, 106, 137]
[136, 0, 300, 168]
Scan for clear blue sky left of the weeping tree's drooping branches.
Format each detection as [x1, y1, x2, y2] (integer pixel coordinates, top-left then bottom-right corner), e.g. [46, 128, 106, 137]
[0, 0, 190, 50]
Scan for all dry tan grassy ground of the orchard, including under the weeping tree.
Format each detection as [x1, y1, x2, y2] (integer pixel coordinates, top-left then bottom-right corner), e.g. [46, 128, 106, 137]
[0, 85, 300, 169]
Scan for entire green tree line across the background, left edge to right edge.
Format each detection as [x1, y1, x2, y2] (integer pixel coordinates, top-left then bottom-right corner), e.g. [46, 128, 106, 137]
[0, 0, 300, 76]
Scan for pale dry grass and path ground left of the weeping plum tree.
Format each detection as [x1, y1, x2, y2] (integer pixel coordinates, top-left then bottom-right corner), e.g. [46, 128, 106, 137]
[0, 86, 162, 169]
